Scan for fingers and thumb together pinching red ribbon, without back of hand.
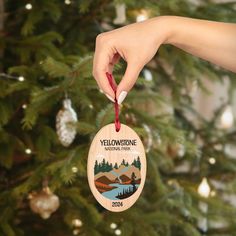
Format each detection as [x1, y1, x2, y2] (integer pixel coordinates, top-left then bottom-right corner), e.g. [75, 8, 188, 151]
[93, 33, 143, 104]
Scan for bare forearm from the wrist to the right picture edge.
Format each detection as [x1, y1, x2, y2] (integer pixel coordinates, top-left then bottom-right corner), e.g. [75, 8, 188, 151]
[156, 16, 236, 72]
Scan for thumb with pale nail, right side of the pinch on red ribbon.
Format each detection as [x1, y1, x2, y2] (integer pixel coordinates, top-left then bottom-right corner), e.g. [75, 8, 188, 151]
[116, 61, 142, 104]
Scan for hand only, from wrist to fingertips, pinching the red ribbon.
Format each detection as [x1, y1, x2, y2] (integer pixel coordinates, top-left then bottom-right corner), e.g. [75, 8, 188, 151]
[93, 17, 167, 104]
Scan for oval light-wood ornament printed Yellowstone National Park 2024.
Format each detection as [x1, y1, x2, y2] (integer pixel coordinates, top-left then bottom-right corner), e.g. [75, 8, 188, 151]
[87, 124, 146, 212]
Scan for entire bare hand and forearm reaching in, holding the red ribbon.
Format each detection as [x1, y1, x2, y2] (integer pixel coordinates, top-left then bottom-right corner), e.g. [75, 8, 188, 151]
[93, 16, 236, 104]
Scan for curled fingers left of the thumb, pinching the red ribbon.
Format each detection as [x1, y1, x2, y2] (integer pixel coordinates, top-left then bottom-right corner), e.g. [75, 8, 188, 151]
[93, 34, 119, 102]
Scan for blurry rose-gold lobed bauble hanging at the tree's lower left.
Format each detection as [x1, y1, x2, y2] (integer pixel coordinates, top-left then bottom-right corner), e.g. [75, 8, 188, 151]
[29, 187, 60, 219]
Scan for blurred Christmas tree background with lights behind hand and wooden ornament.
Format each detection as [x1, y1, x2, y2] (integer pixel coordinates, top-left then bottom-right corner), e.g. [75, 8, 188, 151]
[0, 0, 236, 236]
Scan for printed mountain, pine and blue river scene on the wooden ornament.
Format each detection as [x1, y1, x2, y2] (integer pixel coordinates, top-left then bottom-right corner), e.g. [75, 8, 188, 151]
[94, 157, 141, 200]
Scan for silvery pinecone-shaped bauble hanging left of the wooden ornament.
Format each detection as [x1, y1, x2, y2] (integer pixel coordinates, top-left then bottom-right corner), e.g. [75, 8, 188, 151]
[56, 99, 78, 147]
